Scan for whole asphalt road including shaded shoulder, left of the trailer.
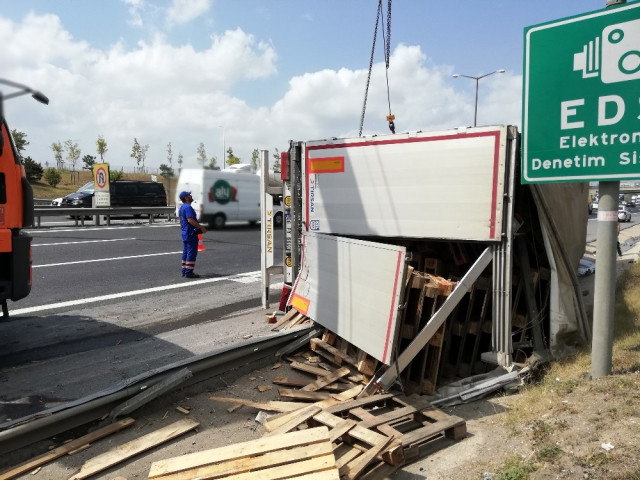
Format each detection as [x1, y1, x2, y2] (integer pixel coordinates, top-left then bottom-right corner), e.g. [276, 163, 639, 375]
[0, 221, 282, 426]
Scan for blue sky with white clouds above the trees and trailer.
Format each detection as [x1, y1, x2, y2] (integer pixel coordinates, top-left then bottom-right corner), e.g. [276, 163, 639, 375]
[0, 0, 605, 169]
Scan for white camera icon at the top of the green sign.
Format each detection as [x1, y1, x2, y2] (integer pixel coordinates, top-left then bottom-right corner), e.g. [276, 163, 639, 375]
[573, 20, 640, 83]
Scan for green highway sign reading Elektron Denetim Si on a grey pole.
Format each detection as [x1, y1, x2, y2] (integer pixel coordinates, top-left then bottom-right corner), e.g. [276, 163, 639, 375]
[522, 1, 640, 183]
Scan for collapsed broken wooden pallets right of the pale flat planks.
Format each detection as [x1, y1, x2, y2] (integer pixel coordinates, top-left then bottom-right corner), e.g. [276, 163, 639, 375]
[264, 392, 467, 480]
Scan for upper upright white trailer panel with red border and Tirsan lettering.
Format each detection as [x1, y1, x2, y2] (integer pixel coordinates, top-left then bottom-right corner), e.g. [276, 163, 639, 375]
[303, 126, 507, 242]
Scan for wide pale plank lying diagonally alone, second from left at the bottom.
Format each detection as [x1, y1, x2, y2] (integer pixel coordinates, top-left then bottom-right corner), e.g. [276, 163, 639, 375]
[69, 419, 200, 480]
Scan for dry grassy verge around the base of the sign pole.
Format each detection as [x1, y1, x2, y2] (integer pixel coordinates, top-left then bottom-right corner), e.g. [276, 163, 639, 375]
[494, 263, 640, 480]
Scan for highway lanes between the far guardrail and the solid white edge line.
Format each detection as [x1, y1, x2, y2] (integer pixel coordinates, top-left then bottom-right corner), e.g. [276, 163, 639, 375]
[9, 222, 281, 315]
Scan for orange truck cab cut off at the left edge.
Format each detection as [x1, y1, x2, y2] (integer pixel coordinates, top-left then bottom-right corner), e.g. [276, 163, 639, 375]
[0, 118, 33, 317]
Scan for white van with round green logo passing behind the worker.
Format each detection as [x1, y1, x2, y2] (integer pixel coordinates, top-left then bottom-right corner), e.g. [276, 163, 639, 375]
[176, 168, 284, 229]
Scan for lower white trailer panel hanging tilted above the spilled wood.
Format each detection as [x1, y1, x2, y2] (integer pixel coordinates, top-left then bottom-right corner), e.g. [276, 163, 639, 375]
[288, 232, 406, 365]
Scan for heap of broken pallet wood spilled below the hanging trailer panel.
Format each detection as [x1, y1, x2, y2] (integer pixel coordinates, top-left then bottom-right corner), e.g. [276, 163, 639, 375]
[208, 332, 467, 480]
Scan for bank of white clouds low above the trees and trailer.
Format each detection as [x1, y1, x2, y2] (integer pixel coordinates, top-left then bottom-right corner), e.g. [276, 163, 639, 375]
[0, 11, 521, 173]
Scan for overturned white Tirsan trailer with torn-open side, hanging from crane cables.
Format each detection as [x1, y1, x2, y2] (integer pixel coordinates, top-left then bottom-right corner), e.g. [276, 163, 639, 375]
[260, 126, 589, 396]
